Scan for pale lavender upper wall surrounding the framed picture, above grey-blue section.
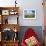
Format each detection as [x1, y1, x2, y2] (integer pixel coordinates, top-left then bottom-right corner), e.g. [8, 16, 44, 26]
[19, 0, 43, 26]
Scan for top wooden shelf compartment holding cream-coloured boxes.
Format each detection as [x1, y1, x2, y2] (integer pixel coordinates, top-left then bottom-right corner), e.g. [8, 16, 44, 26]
[0, 7, 19, 15]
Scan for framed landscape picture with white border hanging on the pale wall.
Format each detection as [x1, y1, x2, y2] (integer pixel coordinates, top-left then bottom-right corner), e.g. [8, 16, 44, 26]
[23, 9, 36, 19]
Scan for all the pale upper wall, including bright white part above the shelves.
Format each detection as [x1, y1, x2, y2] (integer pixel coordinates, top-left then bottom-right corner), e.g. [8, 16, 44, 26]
[0, 0, 43, 26]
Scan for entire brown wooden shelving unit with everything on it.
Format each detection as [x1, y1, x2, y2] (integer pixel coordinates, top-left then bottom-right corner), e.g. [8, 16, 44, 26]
[0, 7, 20, 46]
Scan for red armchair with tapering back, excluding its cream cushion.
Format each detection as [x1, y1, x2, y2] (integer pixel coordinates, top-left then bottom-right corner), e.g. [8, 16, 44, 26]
[21, 28, 41, 46]
